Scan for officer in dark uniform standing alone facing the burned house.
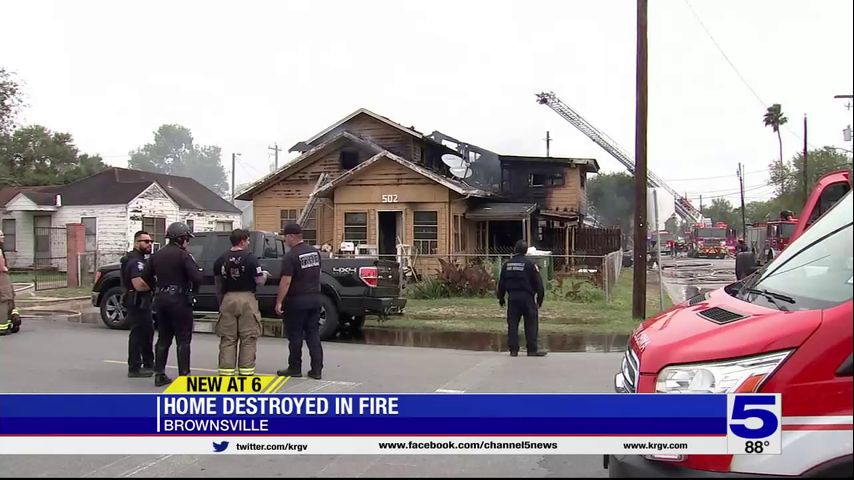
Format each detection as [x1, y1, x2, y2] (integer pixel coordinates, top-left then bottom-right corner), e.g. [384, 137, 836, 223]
[496, 240, 546, 357]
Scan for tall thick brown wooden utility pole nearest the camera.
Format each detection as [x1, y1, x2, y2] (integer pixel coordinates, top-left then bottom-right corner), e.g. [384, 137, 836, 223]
[632, 0, 648, 319]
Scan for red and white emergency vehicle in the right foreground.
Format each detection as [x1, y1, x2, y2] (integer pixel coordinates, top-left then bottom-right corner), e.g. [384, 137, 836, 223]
[605, 172, 854, 478]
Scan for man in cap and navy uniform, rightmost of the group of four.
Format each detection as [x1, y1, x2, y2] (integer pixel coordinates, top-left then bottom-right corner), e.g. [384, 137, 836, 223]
[276, 223, 323, 380]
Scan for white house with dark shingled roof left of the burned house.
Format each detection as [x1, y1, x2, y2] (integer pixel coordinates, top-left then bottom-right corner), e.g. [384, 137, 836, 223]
[0, 168, 242, 268]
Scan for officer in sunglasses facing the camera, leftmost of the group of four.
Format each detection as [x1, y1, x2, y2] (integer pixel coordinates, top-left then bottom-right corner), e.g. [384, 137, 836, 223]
[121, 230, 154, 378]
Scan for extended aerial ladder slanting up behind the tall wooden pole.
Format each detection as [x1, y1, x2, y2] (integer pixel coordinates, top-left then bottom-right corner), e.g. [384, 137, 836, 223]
[536, 92, 703, 223]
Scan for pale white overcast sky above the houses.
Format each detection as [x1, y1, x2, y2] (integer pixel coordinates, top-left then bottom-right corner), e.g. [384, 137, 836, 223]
[0, 0, 854, 213]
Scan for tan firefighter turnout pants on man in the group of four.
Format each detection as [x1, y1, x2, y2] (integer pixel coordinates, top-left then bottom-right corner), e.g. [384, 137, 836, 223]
[216, 292, 262, 376]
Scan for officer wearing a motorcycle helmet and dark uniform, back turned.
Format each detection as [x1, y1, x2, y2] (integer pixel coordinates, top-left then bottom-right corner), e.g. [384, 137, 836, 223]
[143, 222, 202, 387]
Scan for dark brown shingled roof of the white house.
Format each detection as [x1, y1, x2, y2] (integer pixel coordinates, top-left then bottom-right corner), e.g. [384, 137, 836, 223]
[0, 167, 240, 213]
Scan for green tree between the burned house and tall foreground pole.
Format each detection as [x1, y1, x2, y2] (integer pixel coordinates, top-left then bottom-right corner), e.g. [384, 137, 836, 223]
[587, 172, 634, 236]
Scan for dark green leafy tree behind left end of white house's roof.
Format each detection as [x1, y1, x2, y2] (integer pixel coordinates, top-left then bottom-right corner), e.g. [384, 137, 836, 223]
[0, 125, 106, 185]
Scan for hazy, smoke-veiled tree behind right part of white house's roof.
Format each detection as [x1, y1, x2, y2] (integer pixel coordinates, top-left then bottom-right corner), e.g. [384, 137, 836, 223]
[128, 125, 229, 197]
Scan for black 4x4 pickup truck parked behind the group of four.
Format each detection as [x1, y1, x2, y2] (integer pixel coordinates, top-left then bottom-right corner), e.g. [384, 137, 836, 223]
[92, 231, 406, 339]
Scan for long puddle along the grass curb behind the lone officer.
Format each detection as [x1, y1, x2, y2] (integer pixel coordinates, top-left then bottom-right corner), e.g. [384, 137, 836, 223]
[334, 328, 629, 352]
